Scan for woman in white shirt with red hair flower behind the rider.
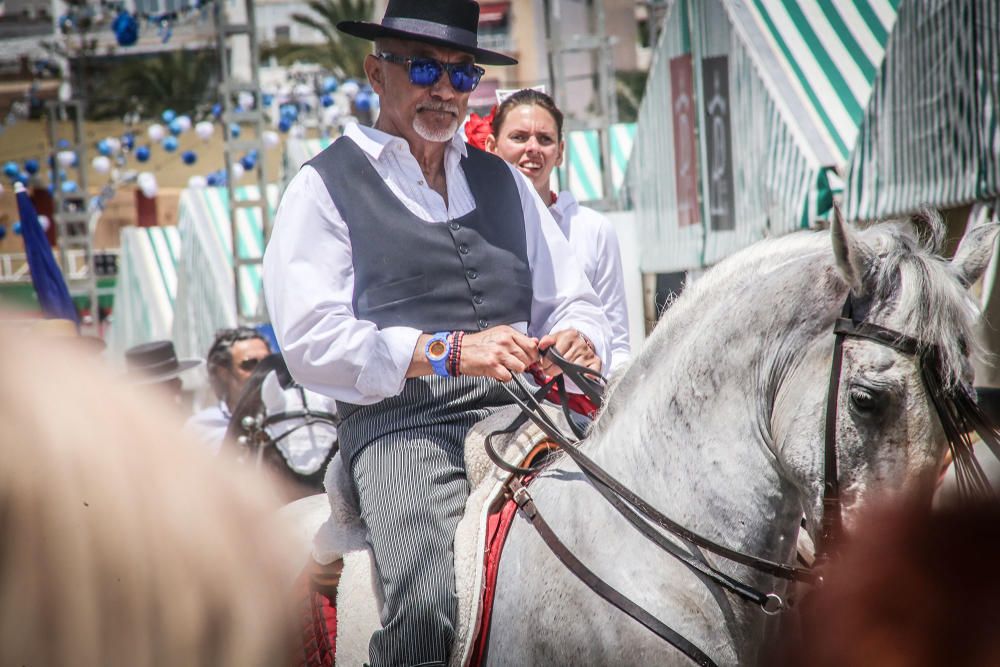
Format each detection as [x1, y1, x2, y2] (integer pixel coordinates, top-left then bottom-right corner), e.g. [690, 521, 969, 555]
[466, 88, 630, 375]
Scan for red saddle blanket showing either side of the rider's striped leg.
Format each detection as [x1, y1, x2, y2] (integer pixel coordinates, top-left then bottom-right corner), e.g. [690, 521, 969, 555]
[299, 500, 517, 667]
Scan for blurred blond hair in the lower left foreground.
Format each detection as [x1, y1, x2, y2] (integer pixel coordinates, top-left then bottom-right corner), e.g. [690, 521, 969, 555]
[0, 330, 294, 667]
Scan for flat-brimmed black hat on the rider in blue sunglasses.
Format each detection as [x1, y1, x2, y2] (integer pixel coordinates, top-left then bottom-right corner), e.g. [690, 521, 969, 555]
[337, 0, 517, 65]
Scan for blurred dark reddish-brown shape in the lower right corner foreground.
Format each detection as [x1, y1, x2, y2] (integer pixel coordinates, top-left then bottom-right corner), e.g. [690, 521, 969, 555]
[776, 498, 1000, 667]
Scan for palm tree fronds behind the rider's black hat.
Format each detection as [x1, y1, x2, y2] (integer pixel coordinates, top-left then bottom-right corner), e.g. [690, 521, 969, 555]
[263, 0, 375, 78]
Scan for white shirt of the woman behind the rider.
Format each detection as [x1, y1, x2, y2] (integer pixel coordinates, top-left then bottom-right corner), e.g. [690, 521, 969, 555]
[549, 191, 632, 375]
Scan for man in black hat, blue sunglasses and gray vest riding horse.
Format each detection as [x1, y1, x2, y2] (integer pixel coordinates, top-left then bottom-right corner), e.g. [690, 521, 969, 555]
[264, 0, 610, 667]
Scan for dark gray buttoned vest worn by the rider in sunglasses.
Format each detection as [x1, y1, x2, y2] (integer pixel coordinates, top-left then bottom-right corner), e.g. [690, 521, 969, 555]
[306, 137, 532, 333]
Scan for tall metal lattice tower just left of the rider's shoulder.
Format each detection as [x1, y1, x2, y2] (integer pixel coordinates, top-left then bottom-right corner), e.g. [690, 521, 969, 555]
[214, 0, 271, 325]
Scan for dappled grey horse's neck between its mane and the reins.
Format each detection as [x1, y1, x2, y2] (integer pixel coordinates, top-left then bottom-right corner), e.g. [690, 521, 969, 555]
[588, 247, 838, 568]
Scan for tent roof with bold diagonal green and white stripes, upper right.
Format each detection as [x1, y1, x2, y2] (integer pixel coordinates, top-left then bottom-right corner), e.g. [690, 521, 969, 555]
[725, 0, 900, 167]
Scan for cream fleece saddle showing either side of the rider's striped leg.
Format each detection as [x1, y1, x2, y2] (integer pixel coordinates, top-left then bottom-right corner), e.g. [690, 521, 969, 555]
[282, 406, 568, 666]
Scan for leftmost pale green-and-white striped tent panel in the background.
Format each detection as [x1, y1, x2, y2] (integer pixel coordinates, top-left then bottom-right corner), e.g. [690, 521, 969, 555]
[106, 227, 181, 357]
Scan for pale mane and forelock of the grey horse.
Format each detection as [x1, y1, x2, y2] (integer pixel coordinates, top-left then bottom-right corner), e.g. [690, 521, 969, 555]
[594, 210, 980, 434]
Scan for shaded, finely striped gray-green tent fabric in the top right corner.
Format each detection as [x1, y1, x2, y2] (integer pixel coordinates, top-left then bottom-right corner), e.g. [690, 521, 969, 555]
[844, 0, 1000, 220]
